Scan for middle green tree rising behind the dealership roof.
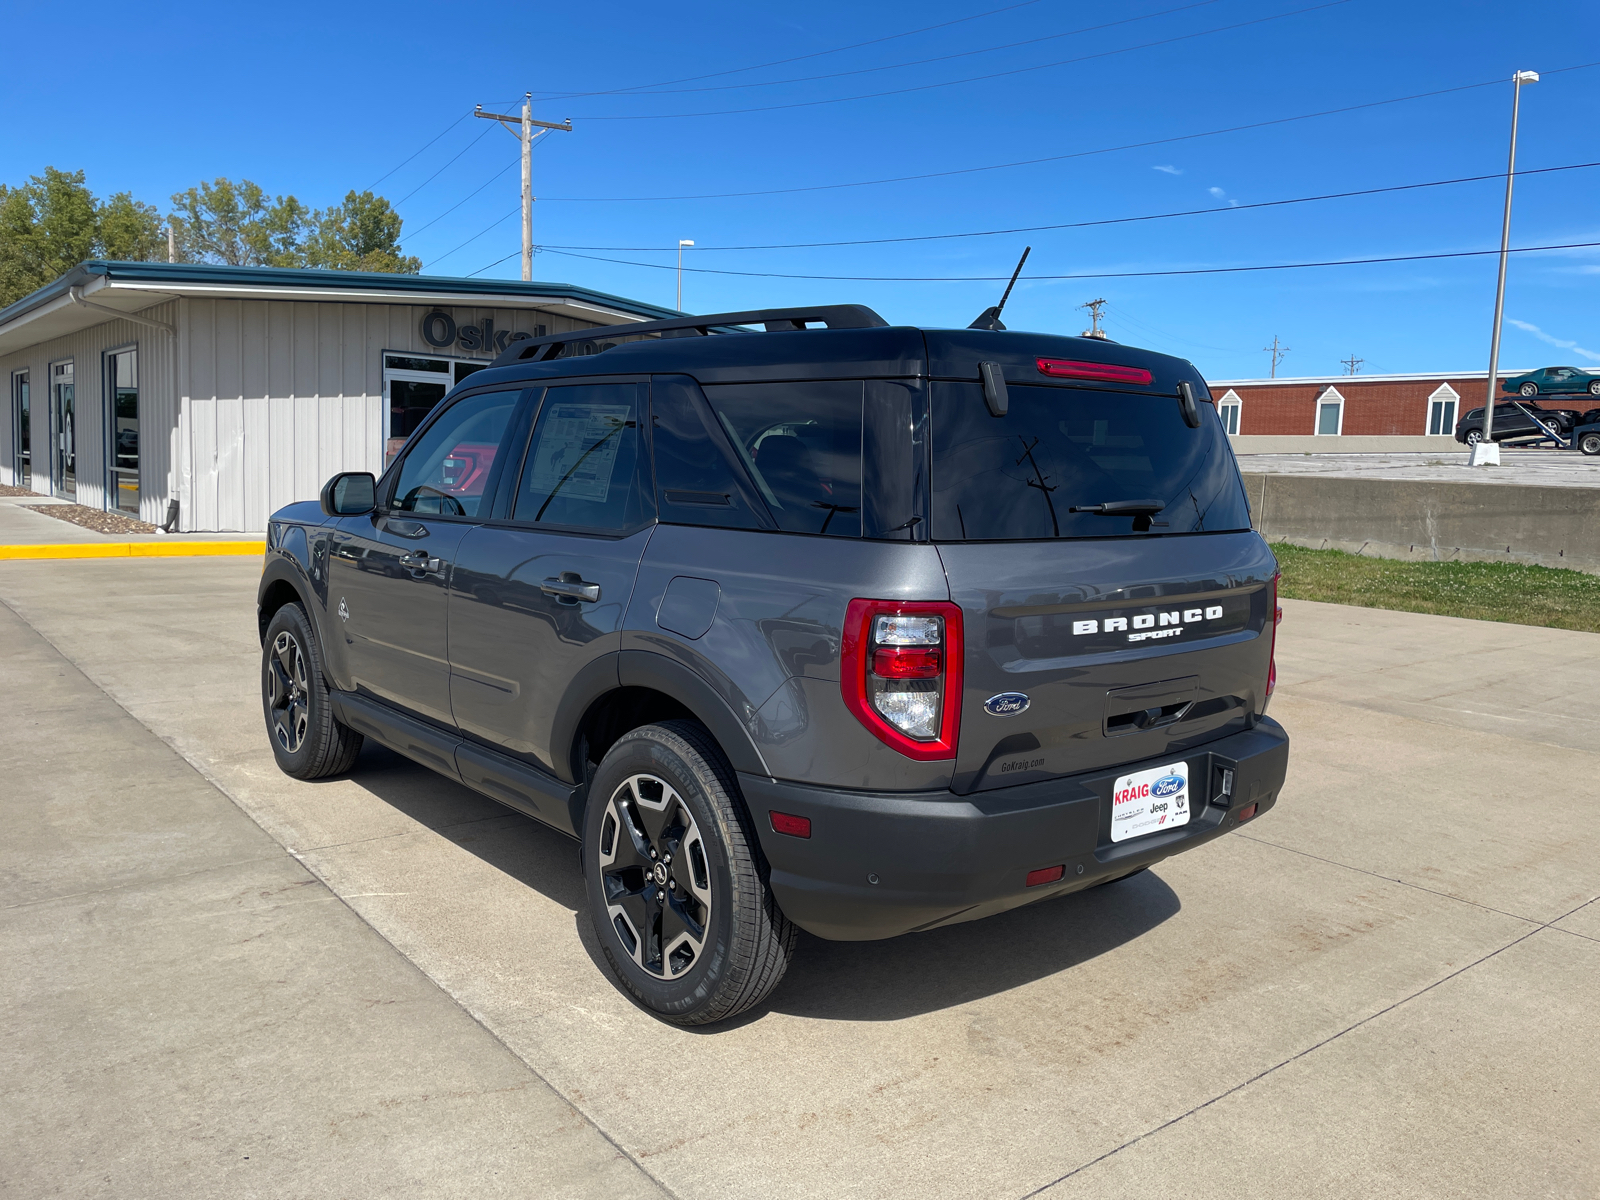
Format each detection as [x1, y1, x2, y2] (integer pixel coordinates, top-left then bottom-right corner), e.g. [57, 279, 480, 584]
[170, 179, 317, 267]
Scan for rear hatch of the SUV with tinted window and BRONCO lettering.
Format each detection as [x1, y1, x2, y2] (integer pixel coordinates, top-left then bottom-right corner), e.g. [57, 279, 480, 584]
[930, 334, 1277, 794]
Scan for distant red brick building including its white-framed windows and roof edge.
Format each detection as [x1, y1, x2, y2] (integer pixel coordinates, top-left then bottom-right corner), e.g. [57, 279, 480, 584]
[1210, 371, 1523, 437]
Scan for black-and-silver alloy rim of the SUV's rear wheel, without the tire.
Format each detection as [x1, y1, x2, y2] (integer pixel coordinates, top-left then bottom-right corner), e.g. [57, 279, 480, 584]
[598, 774, 712, 979]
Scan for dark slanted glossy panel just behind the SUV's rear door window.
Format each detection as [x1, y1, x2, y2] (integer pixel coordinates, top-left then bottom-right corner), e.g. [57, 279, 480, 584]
[650, 376, 771, 530]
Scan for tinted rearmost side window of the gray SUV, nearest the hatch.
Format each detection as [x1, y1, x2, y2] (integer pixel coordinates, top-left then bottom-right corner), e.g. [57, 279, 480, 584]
[706, 382, 862, 538]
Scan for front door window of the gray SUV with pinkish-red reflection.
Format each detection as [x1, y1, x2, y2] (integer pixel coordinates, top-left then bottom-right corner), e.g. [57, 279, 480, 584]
[390, 390, 522, 517]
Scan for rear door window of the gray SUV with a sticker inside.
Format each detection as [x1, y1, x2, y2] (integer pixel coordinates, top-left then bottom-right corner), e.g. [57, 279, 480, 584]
[512, 384, 653, 533]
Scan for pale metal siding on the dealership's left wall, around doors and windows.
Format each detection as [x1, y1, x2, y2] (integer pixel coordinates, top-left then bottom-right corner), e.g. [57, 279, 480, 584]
[0, 302, 178, 525]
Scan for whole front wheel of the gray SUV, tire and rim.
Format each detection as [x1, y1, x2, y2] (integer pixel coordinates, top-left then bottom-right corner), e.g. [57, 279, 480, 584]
[261, 605, 362, 779]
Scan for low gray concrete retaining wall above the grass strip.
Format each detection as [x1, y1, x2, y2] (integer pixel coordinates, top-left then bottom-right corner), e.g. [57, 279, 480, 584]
[1245, 473, 1600, 574]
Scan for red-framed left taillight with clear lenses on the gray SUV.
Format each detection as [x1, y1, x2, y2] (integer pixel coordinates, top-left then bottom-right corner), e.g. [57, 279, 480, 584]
[838, 600, 962, 760]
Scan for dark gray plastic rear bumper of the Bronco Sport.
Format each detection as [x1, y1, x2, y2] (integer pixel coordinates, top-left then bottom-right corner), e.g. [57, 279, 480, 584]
[739, 717, 1290, 941]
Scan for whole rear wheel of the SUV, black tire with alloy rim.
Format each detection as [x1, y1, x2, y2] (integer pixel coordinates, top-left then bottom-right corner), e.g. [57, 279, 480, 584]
[582, 720, 795, 1026]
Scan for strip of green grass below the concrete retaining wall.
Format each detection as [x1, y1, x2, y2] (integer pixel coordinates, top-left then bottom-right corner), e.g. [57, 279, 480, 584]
[1272, 542, 1600, 634]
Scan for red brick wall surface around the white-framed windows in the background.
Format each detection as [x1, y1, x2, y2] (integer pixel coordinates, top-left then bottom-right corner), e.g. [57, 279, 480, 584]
[1211, 376, 1504, 437]
